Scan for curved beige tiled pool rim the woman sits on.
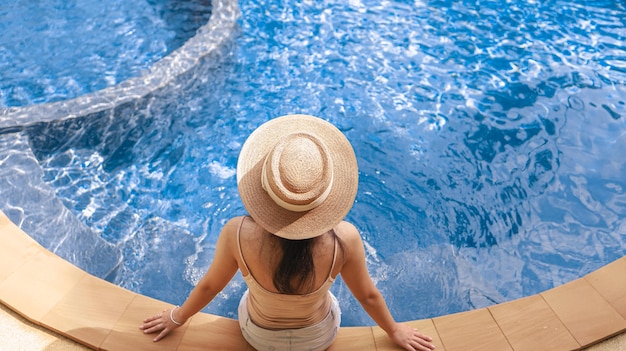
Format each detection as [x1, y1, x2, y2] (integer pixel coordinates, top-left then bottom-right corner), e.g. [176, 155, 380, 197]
[0, 211, 626, 351]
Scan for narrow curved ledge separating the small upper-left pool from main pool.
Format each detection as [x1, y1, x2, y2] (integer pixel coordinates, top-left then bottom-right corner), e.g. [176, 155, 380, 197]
[0, 0, 241, 132]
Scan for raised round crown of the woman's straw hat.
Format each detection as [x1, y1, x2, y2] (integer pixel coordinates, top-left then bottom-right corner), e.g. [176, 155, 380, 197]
[263, 133, 333, 212]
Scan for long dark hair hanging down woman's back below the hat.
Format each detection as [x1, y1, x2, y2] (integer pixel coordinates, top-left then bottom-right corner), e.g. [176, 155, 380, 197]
[272, 230, 343, 294]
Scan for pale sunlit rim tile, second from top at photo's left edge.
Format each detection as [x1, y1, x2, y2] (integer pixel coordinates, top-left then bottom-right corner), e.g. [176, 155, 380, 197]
[0, 250, 87, 323]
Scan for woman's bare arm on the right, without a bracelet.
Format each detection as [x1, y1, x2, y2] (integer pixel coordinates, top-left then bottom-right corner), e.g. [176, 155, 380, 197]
[336, 222, 435, 351]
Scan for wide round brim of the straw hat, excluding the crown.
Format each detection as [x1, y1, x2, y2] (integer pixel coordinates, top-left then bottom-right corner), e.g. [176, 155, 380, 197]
[237, 115, 359, 240]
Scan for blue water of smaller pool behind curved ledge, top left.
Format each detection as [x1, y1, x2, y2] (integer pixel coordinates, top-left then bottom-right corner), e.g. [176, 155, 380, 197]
[0, 0, 211, 107]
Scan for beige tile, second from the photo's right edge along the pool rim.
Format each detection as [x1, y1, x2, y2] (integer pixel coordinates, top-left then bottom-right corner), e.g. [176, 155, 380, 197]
[541, 278, 626, 346]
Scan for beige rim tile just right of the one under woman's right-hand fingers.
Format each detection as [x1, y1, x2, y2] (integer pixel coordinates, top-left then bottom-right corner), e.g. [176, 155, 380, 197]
[433, 308, 512, 351]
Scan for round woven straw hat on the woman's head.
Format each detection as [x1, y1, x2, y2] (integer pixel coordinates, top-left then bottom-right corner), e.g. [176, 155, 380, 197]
[237, 115, 359, 240]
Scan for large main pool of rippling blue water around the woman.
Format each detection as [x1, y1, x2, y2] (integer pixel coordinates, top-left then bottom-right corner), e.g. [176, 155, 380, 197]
[0, 0, 626, 325]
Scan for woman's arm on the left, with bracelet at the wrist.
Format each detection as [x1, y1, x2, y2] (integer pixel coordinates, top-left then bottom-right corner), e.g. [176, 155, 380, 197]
[139, 217, 242, 342]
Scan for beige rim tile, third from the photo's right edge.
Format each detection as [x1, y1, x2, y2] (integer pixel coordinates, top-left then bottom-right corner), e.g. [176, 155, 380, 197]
[488, 295, 580, 351]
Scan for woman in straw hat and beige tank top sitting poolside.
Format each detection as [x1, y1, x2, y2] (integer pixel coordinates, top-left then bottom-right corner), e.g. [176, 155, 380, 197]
[140, 115, 435, 351]
